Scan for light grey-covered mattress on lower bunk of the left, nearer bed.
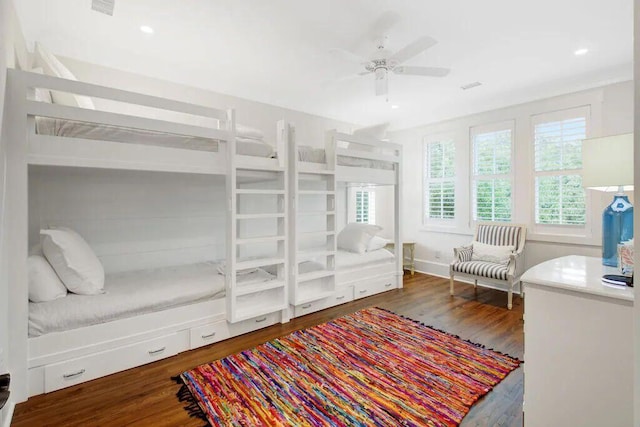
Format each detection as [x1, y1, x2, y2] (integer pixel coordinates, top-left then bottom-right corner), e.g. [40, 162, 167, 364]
[29, 262, 235, 337]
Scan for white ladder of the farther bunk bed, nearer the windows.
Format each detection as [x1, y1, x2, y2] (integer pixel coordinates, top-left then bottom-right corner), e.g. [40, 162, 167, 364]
[289, 126, 336, 316]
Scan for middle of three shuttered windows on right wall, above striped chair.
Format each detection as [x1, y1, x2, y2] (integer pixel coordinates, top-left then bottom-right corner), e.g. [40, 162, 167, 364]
[471, 122, 513, 222]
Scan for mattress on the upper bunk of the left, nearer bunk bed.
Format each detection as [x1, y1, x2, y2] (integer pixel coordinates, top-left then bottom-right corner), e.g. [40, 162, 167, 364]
[36, 117, 274, 157]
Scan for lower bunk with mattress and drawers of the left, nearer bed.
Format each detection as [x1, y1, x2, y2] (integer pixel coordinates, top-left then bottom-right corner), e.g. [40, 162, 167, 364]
[28, 262, 283, 396]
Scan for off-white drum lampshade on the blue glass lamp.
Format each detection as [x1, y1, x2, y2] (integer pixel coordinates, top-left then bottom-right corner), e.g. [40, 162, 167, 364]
[582, 133, 633, 191]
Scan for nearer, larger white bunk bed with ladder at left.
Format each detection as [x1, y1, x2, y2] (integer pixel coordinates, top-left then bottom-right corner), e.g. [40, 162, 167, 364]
[4, 70, 288, 401]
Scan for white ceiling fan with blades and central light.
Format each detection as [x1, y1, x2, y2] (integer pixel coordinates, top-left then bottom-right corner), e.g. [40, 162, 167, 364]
[332, 12, 450, 95]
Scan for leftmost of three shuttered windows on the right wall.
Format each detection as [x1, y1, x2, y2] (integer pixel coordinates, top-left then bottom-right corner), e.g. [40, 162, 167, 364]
[423, 140, 456, 223]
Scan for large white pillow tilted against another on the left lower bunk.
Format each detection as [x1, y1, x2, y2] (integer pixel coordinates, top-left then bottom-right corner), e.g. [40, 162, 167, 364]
[40, 227, 104, 295]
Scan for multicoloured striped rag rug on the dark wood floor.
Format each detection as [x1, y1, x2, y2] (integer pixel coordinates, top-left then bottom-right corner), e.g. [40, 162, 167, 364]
[178, 308, 521, 426]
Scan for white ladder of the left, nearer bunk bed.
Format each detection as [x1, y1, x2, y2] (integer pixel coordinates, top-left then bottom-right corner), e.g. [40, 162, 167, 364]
[225, 117, 289, 324]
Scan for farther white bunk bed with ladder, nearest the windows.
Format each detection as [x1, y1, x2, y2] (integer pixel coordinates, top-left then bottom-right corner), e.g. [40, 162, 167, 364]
[288, 127, 403, 317]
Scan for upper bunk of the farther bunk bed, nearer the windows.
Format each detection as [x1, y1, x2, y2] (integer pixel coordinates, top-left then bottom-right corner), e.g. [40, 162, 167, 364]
[289, 126, 402, 185]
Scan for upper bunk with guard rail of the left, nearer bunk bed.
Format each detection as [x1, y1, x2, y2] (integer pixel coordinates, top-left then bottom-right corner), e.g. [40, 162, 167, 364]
[8, 70, 286, 175]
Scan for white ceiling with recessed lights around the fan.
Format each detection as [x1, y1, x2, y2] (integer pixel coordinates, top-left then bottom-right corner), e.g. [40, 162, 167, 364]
[13, 0, 633, 129]
